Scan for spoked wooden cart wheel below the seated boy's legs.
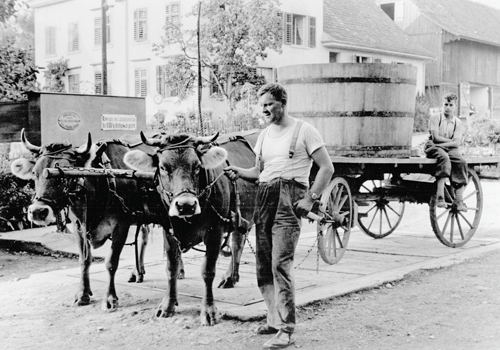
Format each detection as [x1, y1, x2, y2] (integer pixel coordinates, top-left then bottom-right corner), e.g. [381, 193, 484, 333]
[429, 168, 483, 248]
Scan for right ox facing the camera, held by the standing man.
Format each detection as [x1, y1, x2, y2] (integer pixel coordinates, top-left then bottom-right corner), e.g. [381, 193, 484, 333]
[124, 132, 256, 325]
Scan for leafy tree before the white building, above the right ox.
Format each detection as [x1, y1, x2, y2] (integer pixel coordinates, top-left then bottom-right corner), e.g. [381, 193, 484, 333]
[155, 0, 282, 108]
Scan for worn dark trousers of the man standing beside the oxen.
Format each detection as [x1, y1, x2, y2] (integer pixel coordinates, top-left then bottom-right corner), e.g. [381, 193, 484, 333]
[254, 179, 307, 333]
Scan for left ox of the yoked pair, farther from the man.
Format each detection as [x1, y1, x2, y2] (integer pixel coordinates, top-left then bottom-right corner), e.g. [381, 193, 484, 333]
[11, 130, 169, 310]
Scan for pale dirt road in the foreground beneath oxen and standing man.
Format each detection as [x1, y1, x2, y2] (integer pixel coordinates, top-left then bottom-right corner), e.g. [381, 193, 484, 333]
[0, 243, 500, 350]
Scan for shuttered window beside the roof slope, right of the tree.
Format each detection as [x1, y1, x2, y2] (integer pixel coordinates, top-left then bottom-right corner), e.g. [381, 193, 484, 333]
[283, 13, 316, 47]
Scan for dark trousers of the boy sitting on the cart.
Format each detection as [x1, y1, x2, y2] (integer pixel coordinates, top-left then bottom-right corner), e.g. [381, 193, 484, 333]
[425, 145, 467, 187]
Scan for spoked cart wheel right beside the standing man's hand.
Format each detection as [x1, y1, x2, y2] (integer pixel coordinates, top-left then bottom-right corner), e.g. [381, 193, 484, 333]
[318, 177, 353, 265]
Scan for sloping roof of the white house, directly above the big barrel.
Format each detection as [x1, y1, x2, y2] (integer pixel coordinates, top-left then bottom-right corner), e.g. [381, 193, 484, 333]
[323, 0, 435, 59]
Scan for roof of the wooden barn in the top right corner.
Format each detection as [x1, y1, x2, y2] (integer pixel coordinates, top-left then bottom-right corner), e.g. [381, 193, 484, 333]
[412, 0, 500, 46]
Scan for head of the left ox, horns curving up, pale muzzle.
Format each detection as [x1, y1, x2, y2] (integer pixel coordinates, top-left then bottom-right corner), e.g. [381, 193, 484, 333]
[11, 129, 95, 226]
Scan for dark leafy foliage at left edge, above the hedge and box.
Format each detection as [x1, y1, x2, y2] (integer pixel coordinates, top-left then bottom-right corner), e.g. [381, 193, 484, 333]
[0, 41, 38, 101]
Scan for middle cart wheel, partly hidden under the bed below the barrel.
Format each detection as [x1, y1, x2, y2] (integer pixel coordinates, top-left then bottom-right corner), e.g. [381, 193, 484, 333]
[357, 180, 405, 238]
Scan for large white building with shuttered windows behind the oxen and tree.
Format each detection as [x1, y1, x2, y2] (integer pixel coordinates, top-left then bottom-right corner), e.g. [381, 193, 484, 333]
[27, 0, 433, 123]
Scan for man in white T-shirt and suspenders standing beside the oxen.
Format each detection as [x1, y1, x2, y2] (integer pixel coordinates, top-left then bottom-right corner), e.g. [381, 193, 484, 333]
[225, 83, 333, 349]
